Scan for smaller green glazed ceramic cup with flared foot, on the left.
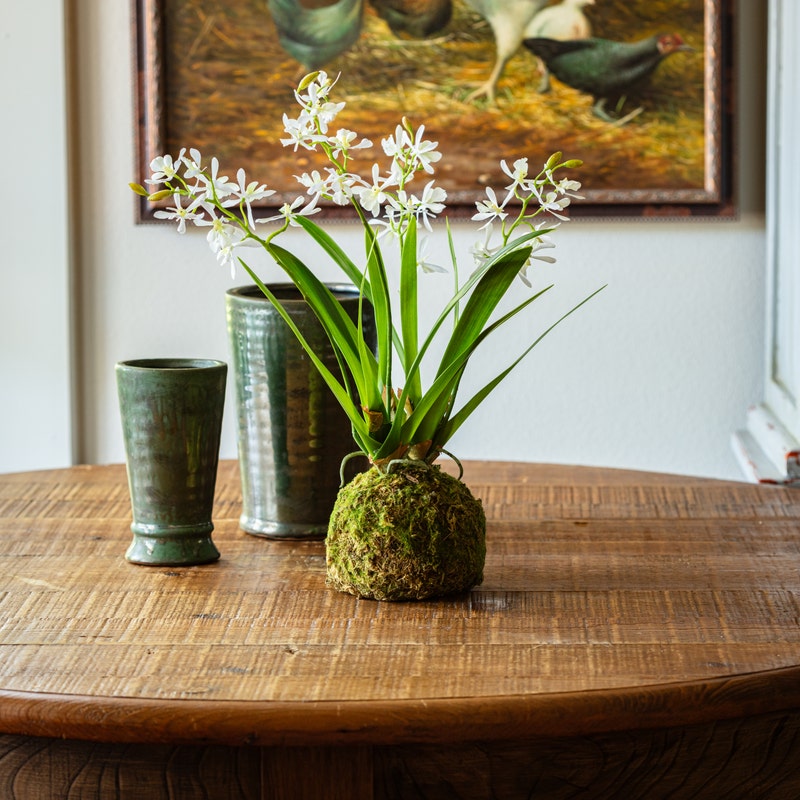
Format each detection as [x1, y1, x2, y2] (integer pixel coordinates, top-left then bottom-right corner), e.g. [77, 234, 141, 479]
[116, 358, 228, 566]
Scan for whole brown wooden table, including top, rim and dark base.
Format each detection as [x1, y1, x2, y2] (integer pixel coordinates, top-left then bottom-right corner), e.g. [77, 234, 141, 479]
[0, 462, 800, 800]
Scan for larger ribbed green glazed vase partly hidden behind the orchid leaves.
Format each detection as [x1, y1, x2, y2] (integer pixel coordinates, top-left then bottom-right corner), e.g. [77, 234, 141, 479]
[226, 284, 375, 539]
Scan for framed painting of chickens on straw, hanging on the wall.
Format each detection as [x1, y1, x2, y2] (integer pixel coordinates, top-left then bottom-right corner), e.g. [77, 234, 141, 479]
[133, 0, 735, 221]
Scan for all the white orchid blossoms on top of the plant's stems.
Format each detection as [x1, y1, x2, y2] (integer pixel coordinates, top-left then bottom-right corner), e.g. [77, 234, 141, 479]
[132, 71, 580, 283]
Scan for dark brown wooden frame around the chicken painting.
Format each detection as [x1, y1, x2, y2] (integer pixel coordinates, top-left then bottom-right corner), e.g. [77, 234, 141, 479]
[132, 0, 737, 222]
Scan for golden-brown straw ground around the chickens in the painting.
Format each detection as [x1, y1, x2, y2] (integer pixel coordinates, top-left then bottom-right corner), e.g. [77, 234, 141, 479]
[164, 0, 706, 209]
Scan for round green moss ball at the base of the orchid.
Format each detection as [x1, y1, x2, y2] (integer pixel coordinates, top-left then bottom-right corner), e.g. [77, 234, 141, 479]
[326, 461, 486, 600]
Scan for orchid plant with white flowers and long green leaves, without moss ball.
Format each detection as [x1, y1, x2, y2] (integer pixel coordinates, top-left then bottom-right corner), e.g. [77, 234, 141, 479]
[131, 72, 594, 471]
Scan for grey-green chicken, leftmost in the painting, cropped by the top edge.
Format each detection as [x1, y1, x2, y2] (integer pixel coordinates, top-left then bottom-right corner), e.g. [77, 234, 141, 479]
[267, 0, 363, 72]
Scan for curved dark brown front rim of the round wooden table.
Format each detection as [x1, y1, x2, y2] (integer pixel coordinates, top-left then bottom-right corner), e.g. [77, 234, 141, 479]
[0, 665, 800, 746]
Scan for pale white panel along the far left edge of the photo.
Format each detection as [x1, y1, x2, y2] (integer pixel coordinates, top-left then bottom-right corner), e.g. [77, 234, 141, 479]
[0, 0, 73, 472]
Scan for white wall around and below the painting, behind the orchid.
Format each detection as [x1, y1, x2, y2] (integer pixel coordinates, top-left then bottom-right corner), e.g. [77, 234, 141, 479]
[4, 0, 766, 478]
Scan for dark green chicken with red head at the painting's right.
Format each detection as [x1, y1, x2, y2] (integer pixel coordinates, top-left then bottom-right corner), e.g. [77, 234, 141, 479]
[524, 33, 692, 122]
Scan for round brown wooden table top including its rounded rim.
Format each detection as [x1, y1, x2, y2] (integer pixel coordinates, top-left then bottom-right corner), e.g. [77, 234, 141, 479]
[0, 462, 800, 745]
